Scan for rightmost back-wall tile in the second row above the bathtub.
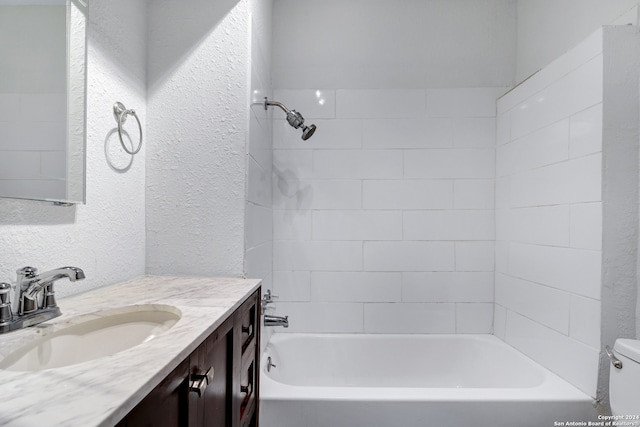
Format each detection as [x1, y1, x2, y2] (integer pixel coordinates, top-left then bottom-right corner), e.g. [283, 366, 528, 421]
[402, 272, 493, 302]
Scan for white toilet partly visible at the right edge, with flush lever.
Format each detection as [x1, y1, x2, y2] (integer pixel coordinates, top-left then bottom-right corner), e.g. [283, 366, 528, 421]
[607, 338, 640, 426]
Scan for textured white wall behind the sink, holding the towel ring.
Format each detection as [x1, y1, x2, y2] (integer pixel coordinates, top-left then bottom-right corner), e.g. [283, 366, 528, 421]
[0, 0, 146, 295]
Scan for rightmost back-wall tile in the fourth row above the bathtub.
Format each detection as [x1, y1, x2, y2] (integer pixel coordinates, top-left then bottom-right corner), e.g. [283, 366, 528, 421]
[403, 210, 495, 240]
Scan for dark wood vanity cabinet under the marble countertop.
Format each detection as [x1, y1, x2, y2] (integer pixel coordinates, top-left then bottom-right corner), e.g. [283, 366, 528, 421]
[117, 290, 260, 427]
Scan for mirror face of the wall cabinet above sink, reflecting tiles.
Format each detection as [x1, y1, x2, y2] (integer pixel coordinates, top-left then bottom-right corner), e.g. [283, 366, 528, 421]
[0, 3, 67, 199]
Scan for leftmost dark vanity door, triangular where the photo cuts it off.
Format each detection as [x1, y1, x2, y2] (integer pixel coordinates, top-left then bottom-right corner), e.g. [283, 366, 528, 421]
[124, 360, 189, 427]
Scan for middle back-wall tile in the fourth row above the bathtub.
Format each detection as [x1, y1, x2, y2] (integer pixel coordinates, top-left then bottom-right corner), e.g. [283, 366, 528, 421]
[312, 211, 402, 240]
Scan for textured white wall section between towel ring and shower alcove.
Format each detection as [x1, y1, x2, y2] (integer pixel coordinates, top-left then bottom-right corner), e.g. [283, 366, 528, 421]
[146, 0, 250, 276]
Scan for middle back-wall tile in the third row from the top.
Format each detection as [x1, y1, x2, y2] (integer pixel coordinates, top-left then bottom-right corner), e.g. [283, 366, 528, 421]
[313, 150, 403, 179]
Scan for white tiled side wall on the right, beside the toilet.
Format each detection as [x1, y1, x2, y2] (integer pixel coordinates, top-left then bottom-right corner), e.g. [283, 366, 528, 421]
[494, 32, 603, 396]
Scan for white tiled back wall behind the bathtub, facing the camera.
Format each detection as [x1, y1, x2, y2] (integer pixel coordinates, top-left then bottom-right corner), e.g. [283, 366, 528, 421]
[273, 88, 504, 333]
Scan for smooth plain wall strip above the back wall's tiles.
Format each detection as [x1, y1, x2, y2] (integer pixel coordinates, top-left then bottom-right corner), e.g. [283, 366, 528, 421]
[273, 0, 516, 89]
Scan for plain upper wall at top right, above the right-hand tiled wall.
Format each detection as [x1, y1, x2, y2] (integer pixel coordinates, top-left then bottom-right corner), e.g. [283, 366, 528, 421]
[516, 0, 639, 82]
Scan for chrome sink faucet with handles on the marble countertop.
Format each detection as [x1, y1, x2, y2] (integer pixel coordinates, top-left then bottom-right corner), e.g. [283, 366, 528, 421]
[0, 267, 85, 333]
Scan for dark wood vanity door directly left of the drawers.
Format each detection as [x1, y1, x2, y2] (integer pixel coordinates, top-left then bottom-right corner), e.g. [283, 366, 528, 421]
[189, 319, 233, 427]
